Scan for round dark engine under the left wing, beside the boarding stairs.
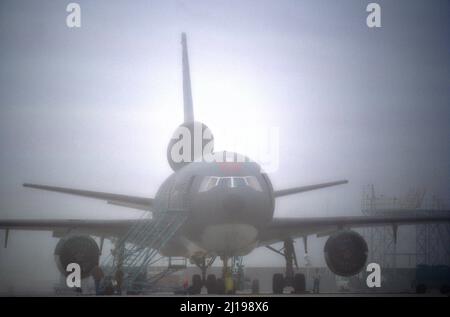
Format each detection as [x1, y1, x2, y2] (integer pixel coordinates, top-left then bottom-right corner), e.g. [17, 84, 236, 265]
[55, 235, 100, 278]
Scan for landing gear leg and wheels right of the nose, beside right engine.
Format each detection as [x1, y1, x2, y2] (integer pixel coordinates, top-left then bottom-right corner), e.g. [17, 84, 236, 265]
[267, 237, 307, 294]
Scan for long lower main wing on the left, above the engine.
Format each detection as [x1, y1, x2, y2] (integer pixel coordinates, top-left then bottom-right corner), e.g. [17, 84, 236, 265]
[0, 219, 142, 238]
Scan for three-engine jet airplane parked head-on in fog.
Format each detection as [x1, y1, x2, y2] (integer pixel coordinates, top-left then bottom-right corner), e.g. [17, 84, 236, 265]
[0, 33, 450, 294]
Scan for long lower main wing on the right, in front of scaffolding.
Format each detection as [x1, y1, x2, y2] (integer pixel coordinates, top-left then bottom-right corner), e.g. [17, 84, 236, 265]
[259, 209, 450, 246]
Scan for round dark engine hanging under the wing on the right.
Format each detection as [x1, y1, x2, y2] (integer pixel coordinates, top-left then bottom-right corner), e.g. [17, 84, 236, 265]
[324, 230, 368, 276]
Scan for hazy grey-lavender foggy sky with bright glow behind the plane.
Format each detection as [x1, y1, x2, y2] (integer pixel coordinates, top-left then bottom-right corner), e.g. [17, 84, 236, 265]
[0, 0, 450, 288]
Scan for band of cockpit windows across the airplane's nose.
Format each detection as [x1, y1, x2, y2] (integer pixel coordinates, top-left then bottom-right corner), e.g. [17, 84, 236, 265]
[198, 176, 262, 193]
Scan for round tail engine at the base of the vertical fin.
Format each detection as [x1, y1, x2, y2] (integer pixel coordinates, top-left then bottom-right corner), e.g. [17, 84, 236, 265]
[167, 122, 214, 171]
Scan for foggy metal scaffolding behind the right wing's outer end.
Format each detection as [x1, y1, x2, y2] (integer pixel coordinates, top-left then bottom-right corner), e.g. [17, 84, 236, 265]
[361, 185, 450, 287]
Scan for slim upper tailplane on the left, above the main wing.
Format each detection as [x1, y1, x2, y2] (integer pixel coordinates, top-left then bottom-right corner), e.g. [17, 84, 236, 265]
[23, 183, 153, 210]
